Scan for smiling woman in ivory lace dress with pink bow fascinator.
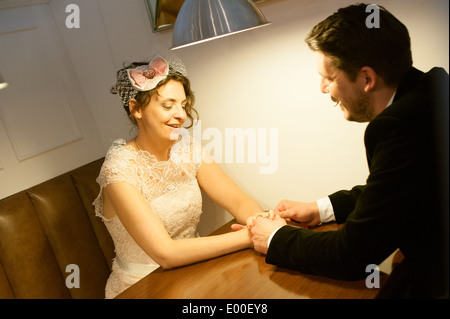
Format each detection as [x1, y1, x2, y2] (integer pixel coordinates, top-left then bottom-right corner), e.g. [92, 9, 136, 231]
[94, 56, 262, 298]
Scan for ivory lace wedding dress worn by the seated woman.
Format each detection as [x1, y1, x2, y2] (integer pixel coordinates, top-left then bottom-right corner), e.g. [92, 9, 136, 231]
[93, 136, 202, 298]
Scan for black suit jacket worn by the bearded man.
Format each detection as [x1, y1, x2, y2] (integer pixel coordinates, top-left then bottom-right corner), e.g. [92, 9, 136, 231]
[266, 68, 449, 297]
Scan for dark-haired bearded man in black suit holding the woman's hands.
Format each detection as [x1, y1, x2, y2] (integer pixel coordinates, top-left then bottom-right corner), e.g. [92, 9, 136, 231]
[251, 4, 449, 298]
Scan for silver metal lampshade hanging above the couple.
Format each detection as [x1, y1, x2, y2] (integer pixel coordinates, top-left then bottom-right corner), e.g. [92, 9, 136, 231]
[171, 0, 270, 50]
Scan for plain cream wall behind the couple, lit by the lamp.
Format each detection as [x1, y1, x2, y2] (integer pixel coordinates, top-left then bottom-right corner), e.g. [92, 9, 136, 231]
[0, 0, 449, 234]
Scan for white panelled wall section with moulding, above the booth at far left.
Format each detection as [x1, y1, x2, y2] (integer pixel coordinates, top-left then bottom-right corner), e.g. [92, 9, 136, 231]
[0, 0, 105, 198]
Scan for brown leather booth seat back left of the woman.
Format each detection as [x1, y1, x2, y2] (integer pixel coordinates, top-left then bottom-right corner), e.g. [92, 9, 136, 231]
[0, 158, 114, 298]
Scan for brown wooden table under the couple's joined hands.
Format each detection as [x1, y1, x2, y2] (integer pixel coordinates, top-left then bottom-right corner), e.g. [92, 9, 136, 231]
[117, 221, 400, 299]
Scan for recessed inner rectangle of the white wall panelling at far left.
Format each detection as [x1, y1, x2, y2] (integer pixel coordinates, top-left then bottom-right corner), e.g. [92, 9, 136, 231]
[0, 27, 81, 161]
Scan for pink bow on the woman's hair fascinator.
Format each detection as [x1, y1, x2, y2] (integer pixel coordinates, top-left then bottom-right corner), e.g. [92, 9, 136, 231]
[127, 57, 169, 91]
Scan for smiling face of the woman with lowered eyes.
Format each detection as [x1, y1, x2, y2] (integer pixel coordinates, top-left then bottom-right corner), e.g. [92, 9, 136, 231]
[138, 80, 187, 141]
